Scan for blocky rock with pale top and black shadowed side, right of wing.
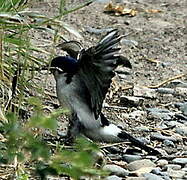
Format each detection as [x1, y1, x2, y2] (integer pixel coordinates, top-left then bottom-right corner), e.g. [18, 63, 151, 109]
[120, 96, 144, 107]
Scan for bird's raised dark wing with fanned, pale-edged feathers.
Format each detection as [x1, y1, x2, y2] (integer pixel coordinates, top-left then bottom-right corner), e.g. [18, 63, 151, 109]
[79, 30, 125, 119]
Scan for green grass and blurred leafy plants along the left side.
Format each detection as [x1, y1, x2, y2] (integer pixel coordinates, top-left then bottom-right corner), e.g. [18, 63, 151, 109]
[0, 0, 107, 180]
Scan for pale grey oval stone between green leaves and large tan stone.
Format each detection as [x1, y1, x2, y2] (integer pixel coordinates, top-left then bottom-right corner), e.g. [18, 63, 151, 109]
[103, 164, 129, 177]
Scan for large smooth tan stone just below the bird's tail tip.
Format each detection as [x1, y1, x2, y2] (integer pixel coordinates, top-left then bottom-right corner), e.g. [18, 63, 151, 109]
[127, 159, 156, 171]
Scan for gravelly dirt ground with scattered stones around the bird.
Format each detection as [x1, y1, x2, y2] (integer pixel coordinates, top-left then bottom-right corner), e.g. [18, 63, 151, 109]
[2, 0, 187, 180]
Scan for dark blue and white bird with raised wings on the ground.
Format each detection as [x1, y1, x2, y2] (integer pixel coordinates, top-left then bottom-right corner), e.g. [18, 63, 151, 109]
[50, 29, 158, 154]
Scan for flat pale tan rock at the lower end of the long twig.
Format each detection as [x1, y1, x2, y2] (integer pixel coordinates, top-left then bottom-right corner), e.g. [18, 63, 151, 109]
[133, 86, 157, 98]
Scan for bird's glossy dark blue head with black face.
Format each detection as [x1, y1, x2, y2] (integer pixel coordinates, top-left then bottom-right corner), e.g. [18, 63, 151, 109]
[50, 56, 78, 75]
